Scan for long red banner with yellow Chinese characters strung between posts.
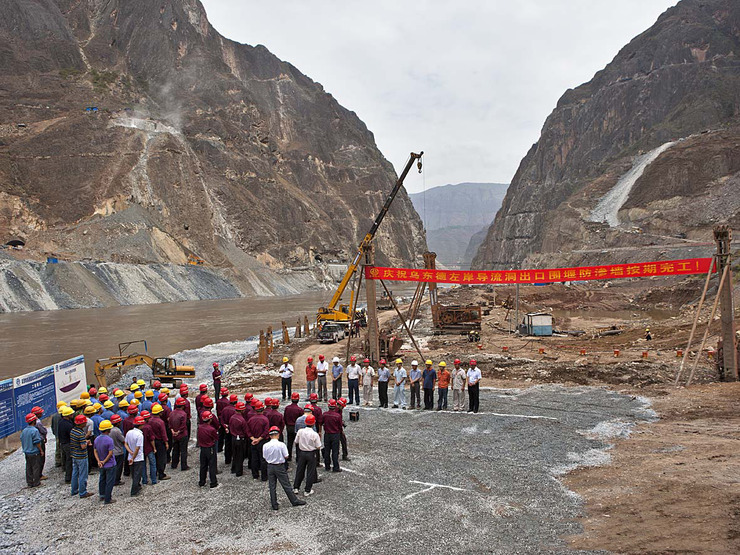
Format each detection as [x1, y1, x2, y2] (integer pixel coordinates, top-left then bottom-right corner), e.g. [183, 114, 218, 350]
[365, 258, 716, 285]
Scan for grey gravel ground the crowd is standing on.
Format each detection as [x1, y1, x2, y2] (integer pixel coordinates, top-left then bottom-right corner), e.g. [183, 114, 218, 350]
[0, 385, 655, 554]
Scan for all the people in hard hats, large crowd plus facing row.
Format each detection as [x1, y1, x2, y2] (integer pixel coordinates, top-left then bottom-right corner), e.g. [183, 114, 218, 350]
[21, 355, 481, 510]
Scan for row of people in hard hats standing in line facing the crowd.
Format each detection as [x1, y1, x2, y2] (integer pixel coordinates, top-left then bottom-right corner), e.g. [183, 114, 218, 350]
[279, 355, 481, 412]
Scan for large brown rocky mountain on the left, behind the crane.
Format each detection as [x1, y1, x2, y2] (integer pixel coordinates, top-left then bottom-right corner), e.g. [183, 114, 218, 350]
[0, 0, 426, 310]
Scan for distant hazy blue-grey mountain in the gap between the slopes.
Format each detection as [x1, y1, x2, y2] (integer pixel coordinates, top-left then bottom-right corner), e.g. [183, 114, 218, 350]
[409, 183, 508, 268]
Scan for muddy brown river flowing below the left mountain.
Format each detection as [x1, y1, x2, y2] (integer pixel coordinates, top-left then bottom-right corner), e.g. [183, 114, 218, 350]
[0, 291, 331, 380]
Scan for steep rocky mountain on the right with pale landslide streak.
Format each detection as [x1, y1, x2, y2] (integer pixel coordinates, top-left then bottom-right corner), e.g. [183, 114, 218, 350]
[473, 0, 740, 268]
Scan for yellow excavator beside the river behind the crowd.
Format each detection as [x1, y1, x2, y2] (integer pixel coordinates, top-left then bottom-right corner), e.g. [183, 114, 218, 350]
[95, 339, 195, 387]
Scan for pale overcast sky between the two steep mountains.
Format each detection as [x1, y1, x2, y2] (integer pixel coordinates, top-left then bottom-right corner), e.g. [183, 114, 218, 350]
[201, 0, 676, 192]
